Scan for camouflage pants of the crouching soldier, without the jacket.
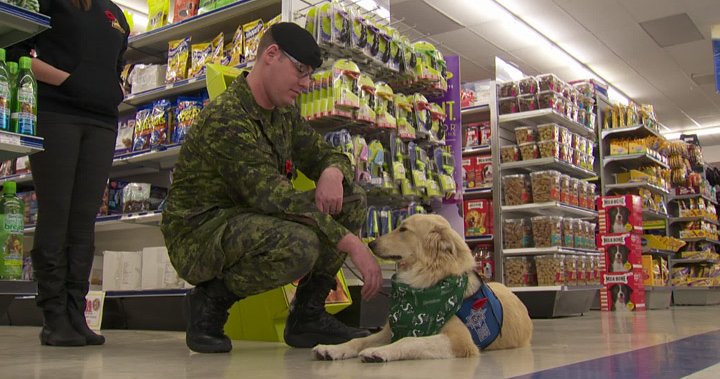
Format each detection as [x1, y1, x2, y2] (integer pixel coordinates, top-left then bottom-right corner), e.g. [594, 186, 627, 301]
[176, 186, 367, 297]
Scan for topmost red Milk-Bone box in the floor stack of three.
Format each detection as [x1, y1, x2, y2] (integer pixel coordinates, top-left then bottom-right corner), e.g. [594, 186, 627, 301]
[596, 195, 643, 234]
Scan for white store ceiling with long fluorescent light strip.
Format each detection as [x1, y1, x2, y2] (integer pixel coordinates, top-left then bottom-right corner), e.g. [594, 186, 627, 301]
[390, 0, 720, 143]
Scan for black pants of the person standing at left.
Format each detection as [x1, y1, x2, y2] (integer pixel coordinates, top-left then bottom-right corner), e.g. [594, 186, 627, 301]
[30, 122, 116, 306]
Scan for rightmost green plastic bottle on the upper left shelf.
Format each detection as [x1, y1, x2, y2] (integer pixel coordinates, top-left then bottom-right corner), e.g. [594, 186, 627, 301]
[11, 57, 37, 135]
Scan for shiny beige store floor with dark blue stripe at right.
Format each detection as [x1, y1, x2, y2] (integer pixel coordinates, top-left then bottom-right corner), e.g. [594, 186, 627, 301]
[0, 306, 720, 379]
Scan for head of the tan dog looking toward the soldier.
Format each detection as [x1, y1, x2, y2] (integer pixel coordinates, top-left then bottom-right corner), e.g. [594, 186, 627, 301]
[370, 215, 475, 285]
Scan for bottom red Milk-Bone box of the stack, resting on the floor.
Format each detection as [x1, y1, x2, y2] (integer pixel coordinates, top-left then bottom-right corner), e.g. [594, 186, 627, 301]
[600, 269, 645, 312]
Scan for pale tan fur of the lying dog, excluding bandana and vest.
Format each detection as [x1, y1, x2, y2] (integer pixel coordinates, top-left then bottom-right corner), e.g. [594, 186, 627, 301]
[313, 215, 533, 362]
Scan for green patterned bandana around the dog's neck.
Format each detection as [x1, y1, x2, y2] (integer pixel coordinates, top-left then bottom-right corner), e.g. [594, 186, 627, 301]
[388, 275, 468, 342]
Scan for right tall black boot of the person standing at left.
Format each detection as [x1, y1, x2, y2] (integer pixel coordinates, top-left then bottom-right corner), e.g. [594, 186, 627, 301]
[66, 246, 105, 345]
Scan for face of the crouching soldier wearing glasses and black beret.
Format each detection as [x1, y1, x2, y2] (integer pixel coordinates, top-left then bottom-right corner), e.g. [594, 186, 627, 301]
[266, 45, 312, 107]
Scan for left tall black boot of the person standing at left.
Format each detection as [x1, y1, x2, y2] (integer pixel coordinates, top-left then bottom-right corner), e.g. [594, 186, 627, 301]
[31, 249, 86, 346]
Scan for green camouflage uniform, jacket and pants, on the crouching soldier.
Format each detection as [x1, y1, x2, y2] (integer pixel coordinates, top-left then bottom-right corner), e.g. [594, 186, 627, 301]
[162, 76, 366, 297]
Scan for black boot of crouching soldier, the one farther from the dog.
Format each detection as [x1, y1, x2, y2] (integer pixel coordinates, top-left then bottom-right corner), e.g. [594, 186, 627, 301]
[185, 279, 240, 353]
